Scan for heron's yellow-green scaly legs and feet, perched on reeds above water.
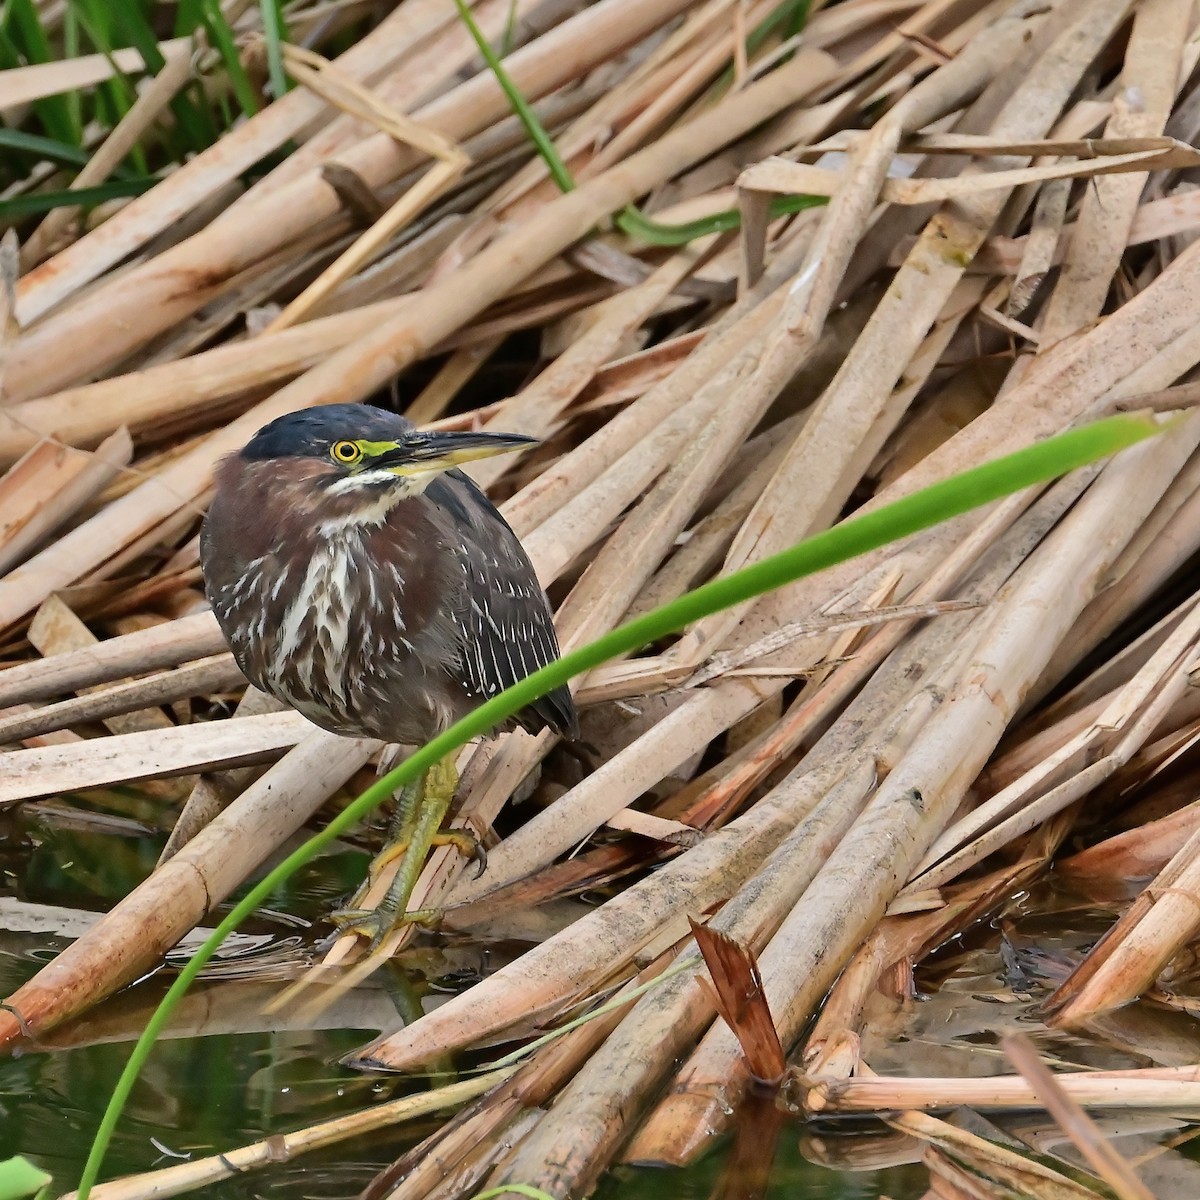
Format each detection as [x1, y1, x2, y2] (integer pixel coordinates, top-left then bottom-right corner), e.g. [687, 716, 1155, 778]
[334, 757, 480, 949]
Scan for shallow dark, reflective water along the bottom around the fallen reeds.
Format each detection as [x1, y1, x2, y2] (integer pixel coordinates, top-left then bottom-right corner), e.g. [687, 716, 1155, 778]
[0, 797, 1200, 1200]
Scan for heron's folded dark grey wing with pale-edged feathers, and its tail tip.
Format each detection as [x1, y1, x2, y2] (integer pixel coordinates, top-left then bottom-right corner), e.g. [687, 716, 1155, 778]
[425, 470, 578, 737]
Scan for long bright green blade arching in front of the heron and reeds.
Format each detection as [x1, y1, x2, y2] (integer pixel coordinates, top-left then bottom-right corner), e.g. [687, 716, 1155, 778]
[77, 415, 1160, 1200]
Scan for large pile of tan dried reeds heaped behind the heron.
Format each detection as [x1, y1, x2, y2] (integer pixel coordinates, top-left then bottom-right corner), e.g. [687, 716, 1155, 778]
[7, 0, 1200, 1200]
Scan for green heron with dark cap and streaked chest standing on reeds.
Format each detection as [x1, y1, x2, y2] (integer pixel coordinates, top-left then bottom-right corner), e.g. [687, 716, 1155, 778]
[200, 404, 578, 944]
